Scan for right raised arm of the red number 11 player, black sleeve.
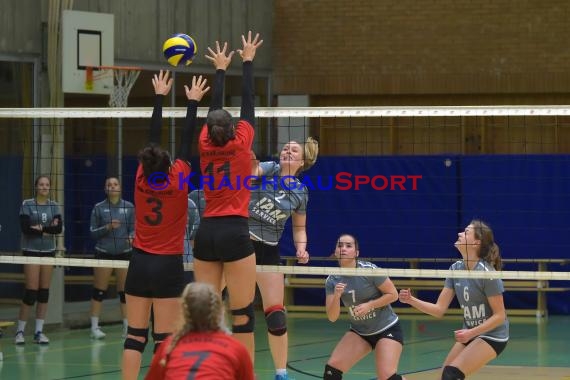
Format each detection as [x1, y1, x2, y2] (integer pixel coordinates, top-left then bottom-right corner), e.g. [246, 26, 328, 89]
[238, 30, 263, 126]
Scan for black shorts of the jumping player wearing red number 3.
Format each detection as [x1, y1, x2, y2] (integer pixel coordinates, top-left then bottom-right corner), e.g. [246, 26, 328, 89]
[125, 248, 185, 298]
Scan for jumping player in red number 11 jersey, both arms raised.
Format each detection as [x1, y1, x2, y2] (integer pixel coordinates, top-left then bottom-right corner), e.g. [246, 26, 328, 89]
[194, 31, 263, 361]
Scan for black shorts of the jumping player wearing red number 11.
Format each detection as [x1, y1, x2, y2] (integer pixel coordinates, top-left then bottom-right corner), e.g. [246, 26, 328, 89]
[194, 216, 254, 262]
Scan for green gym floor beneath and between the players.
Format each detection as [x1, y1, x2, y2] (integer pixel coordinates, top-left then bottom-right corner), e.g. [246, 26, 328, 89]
[0, 313, 570, 380]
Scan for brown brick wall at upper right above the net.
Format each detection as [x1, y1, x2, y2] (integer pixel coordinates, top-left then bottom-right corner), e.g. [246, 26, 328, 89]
[272, 0, 570, 99]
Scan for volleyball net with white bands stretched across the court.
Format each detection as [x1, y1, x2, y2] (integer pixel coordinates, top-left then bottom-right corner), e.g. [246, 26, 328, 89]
[0, 106, 570, 310]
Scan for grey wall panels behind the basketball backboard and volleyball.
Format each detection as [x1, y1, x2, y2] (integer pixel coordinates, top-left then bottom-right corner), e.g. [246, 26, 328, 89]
[0, 0, 273, 71]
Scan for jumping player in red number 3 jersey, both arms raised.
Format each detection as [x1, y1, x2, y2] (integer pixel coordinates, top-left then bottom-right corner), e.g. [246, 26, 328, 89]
[122, 71, 209, 380]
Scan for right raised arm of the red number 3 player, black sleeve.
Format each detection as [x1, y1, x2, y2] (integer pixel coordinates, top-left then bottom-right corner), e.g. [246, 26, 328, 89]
[177, 75, 210, 162]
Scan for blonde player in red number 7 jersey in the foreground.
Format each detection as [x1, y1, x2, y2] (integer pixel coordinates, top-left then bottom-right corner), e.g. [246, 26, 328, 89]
[145, 282, 254, 380]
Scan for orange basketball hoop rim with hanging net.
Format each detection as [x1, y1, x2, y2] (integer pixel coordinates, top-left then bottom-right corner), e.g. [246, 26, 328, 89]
[85, 66, 142, 107]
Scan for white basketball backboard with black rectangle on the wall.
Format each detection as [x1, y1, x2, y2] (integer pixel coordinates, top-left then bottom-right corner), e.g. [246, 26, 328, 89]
[62, 10, 115, 94]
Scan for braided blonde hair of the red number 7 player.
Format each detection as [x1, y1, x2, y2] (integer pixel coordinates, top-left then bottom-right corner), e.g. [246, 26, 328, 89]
[160, 282, 228, 367]
